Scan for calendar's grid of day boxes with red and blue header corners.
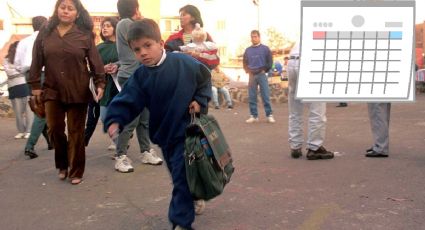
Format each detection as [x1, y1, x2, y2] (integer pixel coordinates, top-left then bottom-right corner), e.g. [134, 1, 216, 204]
[309, 31, 402, 95]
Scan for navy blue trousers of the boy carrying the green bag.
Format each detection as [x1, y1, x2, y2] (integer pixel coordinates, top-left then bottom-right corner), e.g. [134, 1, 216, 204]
[161, 139, 195, 229]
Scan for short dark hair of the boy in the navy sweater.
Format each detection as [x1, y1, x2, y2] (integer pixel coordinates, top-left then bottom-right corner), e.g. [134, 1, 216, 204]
[127, 18, 161, 44]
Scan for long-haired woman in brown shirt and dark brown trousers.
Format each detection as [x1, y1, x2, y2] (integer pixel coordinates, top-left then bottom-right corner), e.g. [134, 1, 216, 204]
[28, 0, 105, 185]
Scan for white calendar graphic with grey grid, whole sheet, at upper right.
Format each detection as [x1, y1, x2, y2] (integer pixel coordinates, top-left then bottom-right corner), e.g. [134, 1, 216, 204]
[296, 0, 415, 102]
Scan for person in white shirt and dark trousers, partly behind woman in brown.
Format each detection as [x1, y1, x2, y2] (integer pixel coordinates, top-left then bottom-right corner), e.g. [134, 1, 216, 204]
[14, 16, 53, 159]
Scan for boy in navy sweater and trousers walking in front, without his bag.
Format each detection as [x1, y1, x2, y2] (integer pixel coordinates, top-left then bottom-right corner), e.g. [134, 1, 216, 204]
[104, 19, 211, 229]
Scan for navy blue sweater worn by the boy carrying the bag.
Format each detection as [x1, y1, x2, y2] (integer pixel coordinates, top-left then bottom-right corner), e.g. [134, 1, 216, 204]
[104, 53, 211, 147]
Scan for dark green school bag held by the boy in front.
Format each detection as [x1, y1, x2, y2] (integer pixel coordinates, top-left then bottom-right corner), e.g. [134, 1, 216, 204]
[185, 114, 235, 200]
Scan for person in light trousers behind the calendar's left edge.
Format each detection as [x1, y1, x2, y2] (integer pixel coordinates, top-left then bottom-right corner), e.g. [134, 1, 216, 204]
[287, 43, 334, 160]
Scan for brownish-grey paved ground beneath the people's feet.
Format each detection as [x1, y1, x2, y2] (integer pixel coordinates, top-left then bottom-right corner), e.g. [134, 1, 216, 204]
[0, 94, 425, 230]
